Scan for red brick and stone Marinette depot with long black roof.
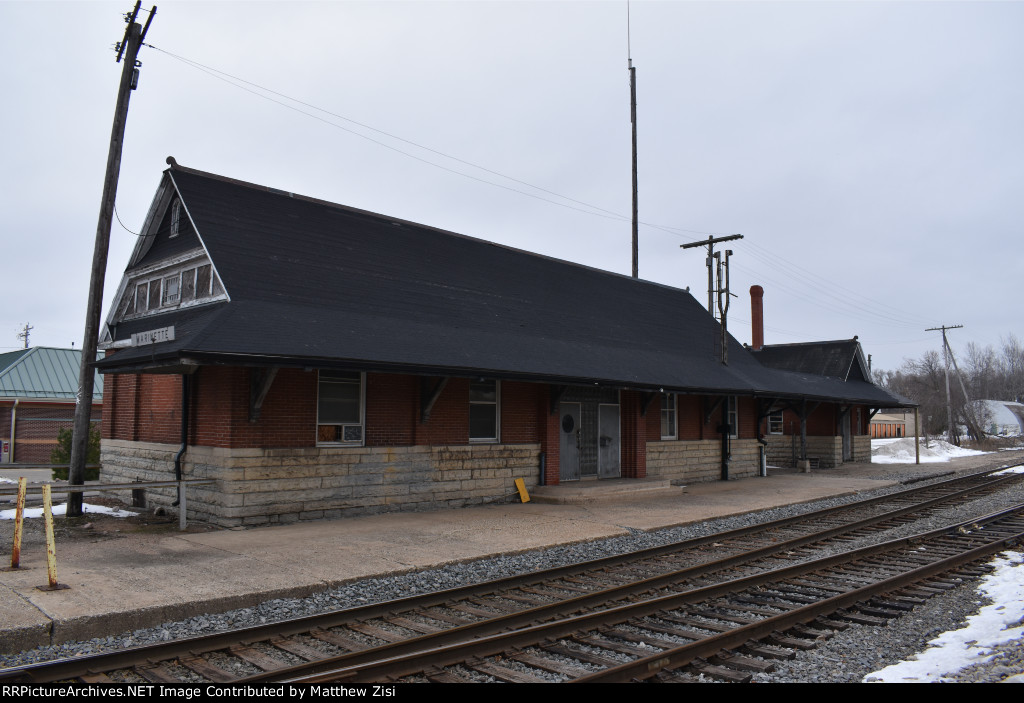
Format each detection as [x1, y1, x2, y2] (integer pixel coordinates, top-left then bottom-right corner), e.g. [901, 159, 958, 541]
[97, 159, 908, 526]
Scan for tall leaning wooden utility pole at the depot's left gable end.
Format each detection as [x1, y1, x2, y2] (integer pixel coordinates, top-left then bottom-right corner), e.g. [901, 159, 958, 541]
[68, 0, 157, 518]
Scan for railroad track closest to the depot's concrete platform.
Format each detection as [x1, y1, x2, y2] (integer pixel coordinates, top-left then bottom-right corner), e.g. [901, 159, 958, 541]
[0, 464, 1022, 683]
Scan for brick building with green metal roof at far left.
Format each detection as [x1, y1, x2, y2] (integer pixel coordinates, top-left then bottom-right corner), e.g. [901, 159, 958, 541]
[0, 347, 103, 464]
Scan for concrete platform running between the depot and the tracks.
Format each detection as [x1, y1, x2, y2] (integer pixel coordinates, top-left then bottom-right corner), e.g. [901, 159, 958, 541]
[0, 450, 1024, 652]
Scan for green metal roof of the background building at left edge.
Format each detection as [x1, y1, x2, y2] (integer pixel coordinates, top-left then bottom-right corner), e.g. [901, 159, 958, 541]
[0, 347, 103, 402]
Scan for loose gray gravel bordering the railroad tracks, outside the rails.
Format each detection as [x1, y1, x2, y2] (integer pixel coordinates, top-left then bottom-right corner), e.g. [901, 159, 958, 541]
[0, 467, 1024, 683]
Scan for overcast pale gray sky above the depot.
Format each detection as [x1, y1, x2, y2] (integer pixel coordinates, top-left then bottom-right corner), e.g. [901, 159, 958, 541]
[0, 0, 1024, 368]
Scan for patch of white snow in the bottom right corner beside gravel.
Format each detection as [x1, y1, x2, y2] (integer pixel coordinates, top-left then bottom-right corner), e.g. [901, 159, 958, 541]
[863, 552, 1024, 684]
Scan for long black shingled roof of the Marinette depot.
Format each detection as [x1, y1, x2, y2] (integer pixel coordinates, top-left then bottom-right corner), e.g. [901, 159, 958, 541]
[98, 165, 913, 405]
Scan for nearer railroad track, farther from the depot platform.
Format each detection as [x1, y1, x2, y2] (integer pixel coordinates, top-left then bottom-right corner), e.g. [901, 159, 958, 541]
[309, 504, 1024, 684]
